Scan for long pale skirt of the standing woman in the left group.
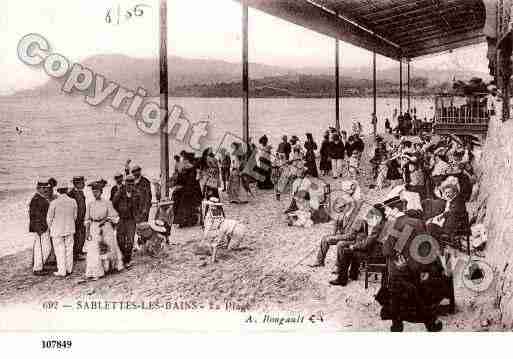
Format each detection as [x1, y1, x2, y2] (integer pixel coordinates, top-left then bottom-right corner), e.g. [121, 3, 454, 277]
[85, 222, 123, 278]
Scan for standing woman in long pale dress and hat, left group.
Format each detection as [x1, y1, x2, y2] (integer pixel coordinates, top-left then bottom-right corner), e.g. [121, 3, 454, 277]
[84, 181, 123, 280]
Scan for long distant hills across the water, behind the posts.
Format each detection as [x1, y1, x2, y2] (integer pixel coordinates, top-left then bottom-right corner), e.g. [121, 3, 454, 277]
[7, 55, 487, 97]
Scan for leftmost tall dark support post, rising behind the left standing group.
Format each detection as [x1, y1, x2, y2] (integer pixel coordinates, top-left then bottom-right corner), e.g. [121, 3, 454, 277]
[159, 0, 169, 199]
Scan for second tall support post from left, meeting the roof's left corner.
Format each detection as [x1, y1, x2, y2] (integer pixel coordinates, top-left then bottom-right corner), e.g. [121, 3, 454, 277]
[241, 0, 249, 146]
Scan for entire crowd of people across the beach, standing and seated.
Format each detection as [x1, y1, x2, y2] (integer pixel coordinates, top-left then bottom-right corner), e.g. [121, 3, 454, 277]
[29, 111, 474, 331]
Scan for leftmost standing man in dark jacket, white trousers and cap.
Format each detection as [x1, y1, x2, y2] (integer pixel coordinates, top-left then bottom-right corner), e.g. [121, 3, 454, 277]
[29, 181, 52, 275]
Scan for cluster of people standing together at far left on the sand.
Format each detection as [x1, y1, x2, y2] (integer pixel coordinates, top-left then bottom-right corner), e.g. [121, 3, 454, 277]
[29, 162, 164, 280]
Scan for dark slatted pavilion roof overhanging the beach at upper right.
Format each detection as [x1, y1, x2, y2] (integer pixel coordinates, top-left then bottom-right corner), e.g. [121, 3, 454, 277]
[239, 0, 486, 59]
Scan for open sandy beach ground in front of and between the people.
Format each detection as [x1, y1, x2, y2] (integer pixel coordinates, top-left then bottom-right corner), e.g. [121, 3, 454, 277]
[0, 137, 496, 331]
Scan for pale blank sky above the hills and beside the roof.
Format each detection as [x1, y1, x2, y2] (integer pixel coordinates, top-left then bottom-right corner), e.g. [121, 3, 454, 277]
[0, 0, 487, 94]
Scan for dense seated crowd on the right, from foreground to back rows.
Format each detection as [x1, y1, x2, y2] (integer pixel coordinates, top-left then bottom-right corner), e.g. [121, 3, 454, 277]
[304, 128, 475, 331]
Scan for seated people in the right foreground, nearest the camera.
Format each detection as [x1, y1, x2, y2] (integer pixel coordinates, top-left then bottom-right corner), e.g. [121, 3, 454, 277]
[310, 176, 469, 331]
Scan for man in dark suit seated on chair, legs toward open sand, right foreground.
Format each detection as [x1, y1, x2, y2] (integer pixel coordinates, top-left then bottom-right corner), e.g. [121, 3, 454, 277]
[330, 205, 385, 286]
